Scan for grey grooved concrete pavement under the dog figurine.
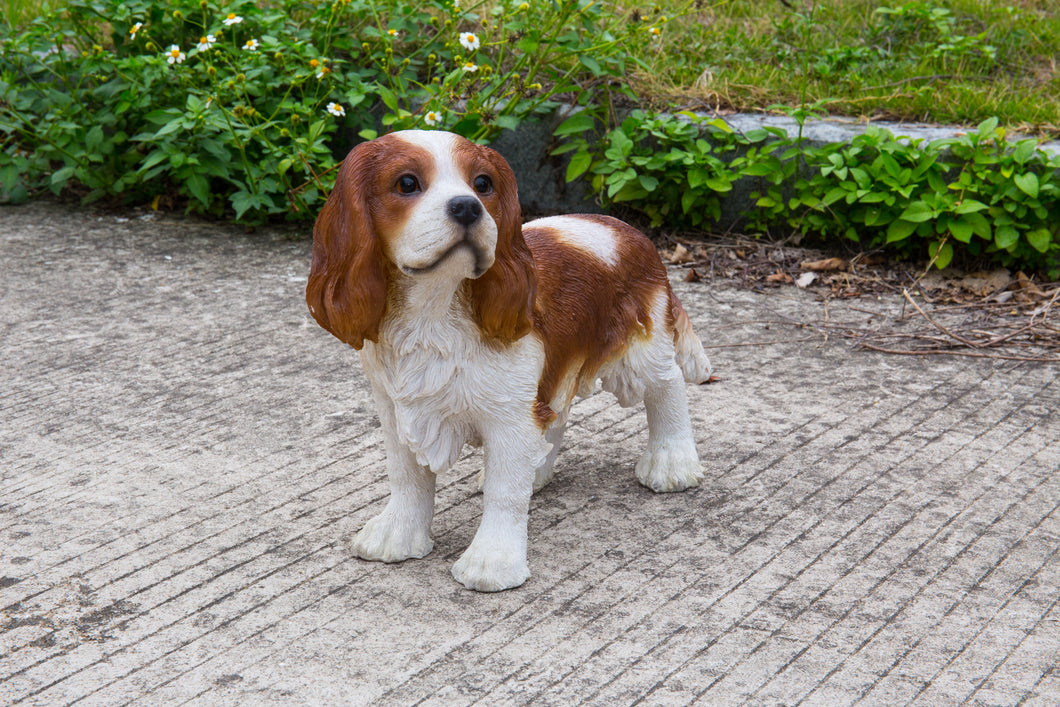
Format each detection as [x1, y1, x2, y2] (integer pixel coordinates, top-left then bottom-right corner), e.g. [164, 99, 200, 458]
[6, 205, 1060, 705]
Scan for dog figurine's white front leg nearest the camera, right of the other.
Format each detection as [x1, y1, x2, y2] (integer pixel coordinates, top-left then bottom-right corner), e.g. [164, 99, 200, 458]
[453, 423, 551, 591]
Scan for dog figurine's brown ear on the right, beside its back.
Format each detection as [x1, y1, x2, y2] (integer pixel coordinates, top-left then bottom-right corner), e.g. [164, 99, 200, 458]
[471, 147, 537, 343]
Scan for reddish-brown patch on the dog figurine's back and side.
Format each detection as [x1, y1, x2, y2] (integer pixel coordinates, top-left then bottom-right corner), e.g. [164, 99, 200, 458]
[523, 215, 679, 428]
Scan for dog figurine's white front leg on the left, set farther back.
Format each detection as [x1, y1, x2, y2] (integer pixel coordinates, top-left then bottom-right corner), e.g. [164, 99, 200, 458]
[352, 401, 435, 562]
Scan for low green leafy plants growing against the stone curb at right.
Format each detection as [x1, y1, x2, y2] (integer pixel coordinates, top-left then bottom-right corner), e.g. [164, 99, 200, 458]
[568, 111, 1060, 277]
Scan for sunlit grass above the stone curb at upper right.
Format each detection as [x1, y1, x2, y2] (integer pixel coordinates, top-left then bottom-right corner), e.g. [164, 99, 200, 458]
[634, 0, 1060, 137]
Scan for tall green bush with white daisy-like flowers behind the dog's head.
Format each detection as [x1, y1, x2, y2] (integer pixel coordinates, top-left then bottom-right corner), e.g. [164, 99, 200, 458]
[0, 0, 651, 220]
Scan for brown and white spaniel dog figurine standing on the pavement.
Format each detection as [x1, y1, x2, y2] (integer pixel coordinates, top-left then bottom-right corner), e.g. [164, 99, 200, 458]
[305, 130, 710, 591]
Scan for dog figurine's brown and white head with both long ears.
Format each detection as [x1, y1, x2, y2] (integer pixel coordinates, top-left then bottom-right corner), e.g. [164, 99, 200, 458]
[305, 130, 536, 349]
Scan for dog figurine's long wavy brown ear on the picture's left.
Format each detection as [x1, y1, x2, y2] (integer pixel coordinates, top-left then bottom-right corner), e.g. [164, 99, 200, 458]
[305, 143, 387, 349]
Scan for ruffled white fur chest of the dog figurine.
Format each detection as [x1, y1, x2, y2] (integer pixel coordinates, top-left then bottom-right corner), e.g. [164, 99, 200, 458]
[361, 303, 544, 473]
